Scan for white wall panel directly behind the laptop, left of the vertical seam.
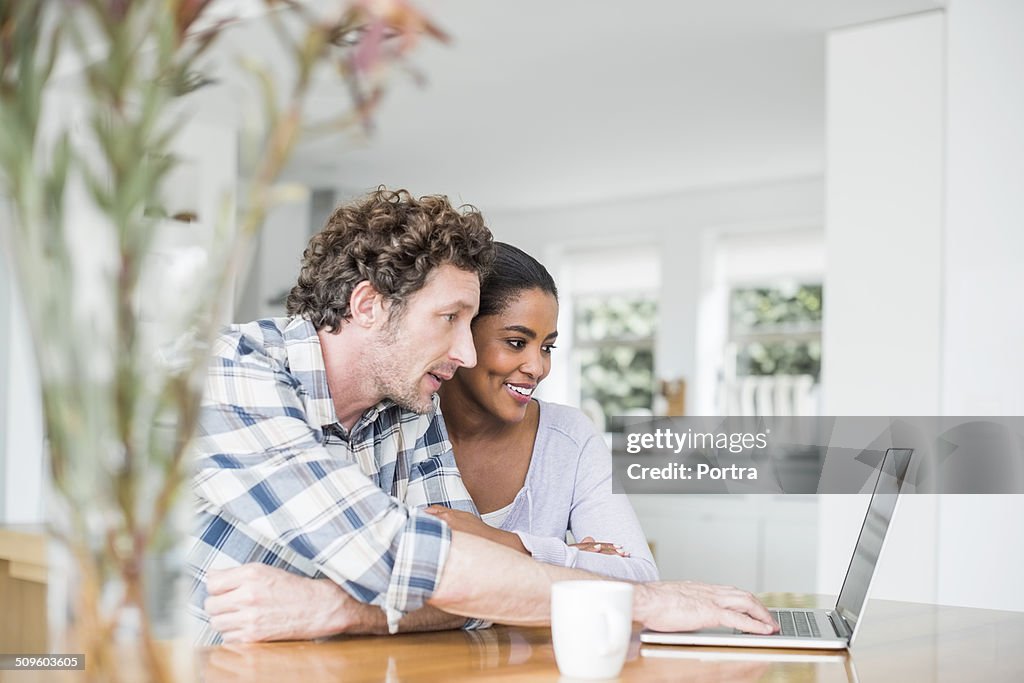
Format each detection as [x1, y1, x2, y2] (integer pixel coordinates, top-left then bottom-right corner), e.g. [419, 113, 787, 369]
[818, 12, 944, 602]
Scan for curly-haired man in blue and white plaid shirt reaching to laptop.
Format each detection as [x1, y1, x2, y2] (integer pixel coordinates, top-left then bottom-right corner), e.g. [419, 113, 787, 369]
[189, 185, 775, 643]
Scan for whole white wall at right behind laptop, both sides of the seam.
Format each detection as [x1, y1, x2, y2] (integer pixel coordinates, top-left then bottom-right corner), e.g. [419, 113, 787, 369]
[818, 0, 1024, 610]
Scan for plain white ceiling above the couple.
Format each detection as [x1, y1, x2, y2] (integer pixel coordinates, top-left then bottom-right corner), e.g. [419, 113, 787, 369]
[270, 0, 944, 210]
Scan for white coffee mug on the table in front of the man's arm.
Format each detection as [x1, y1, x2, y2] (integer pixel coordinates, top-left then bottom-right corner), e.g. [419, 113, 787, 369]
[551, 581, 633, 678]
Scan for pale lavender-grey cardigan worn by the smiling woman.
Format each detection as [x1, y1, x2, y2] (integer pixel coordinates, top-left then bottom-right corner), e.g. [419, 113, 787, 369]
[493, 401, 657, 581]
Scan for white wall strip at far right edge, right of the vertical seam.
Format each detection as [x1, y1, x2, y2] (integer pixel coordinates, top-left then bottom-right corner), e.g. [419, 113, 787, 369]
[938, 0, 1024, 610]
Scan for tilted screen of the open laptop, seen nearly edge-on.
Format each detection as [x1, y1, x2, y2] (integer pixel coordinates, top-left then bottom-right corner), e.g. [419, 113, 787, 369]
[836, 449, 913, 629]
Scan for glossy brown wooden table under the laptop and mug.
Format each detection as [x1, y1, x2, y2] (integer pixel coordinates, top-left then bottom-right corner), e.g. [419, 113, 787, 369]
[193, 594, 1024, 683]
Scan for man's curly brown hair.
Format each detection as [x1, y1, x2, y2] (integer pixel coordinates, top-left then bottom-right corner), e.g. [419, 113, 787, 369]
[287, 186, 495, 331]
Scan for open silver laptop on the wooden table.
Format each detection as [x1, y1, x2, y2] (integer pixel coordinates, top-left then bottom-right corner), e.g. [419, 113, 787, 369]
[640, 449, 913, 650]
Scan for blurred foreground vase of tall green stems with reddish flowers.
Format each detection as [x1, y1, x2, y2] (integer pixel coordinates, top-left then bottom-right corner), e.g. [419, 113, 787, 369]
[0, 0, 444, 681]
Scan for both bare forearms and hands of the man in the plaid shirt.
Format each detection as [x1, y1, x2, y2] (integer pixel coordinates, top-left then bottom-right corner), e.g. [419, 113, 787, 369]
[204, 531, 778, 642]
